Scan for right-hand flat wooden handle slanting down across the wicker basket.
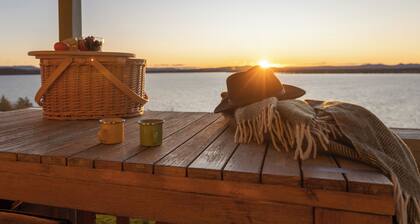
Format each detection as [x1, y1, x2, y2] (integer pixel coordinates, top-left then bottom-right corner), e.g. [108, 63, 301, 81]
[89, 58, 149, 105]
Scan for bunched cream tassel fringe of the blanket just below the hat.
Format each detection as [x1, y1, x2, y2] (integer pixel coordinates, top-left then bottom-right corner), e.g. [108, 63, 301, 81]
[235, 104, 342, 159]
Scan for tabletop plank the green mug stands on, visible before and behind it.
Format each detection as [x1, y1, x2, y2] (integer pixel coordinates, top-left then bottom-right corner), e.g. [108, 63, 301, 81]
[94, 112, 204, 169]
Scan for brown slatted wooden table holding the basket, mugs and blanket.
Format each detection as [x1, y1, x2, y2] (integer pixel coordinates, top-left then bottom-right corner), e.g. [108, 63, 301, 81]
[0, 109, 416, 223]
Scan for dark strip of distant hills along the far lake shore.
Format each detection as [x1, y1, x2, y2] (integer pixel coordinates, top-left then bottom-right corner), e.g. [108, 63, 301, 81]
[0, 64, 420, 75]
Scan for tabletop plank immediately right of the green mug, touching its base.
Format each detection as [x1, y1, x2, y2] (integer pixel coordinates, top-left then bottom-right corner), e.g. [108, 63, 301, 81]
[124, 114, 221, 173]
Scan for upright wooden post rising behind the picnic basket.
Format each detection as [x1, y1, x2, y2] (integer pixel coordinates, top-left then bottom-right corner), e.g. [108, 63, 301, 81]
[58, 0, 82, 40]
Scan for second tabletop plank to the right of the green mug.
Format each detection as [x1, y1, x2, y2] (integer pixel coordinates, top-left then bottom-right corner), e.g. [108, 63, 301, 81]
[154, 117, 229, 177]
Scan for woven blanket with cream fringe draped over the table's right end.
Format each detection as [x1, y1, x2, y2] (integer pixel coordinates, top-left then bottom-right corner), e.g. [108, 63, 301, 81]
[235, 97, 420, 224]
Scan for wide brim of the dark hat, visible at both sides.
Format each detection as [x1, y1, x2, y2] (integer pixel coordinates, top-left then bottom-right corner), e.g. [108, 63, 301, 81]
[214, 84, 305, 113]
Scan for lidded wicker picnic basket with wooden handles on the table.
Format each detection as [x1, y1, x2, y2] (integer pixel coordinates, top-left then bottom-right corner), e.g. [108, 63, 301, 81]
[29, 51, 148, 120]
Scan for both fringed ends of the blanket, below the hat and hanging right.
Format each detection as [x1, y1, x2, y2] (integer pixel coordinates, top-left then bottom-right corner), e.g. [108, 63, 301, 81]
[235, 100, 420, 224]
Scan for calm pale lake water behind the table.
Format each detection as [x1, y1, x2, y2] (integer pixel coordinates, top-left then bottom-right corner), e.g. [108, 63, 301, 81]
[0, 72, 420, 128]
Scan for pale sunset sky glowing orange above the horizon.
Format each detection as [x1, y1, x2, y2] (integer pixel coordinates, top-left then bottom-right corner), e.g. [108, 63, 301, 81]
[0, 0, 420, 67]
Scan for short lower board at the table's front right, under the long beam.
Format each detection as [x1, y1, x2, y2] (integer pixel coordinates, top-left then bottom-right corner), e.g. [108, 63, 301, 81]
[315, 208, 392, 224]
